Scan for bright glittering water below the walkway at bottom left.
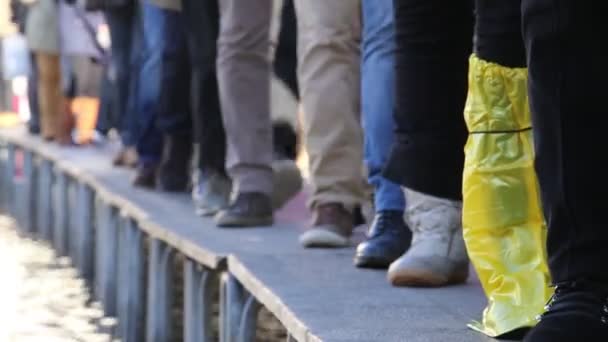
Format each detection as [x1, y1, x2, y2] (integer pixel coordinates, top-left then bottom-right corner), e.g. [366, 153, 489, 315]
[0, 216, 115, 342]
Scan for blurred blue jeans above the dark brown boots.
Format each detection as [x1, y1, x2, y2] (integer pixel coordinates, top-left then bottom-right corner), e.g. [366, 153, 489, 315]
[136, 2, 191, 164]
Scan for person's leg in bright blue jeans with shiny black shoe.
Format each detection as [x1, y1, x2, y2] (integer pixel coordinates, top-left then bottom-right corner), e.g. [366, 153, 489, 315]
[355, 0, 416, 268]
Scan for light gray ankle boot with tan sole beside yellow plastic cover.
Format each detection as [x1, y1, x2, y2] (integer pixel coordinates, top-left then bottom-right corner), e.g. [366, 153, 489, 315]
[388, 189, 469, 287]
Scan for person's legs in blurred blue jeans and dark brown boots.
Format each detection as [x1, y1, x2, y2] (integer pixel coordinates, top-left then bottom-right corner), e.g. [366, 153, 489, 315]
[133, 0, 192, 192]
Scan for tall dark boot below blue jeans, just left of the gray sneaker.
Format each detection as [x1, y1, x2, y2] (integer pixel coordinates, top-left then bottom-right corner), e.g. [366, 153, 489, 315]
[158, 135, 192, 192]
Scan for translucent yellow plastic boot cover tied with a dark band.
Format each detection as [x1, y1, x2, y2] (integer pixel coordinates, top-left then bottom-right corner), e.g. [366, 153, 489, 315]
[463, 56, 552, 337]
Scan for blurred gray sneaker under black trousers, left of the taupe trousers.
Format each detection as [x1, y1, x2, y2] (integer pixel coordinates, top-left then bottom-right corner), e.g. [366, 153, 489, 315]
[192, 171, 232, 216]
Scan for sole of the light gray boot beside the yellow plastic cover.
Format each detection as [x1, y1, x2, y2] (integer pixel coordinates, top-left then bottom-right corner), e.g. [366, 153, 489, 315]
[388, 270, 469, 287]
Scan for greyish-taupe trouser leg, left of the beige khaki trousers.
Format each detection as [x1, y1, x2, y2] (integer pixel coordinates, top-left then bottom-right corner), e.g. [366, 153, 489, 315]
[217, 0, 273, 194]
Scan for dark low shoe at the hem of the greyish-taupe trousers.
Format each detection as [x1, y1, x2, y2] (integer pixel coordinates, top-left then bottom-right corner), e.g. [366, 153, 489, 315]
[215, 192, 274, 228]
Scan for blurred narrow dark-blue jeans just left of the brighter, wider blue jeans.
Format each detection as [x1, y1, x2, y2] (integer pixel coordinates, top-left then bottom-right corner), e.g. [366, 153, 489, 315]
[105, 7, 141, 146]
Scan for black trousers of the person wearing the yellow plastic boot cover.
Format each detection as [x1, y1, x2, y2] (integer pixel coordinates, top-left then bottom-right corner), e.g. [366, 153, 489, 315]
[385, 0, 525, 200]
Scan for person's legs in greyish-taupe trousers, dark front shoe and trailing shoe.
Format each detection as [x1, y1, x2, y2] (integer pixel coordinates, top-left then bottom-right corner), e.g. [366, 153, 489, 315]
[215, 0, 301, 227]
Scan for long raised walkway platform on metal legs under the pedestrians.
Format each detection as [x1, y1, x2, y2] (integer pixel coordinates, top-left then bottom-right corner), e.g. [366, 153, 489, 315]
[0, 129, 490, 342]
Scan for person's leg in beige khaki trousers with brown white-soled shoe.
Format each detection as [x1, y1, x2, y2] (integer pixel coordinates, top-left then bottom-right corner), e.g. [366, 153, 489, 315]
[294, 0, 365, 247]
